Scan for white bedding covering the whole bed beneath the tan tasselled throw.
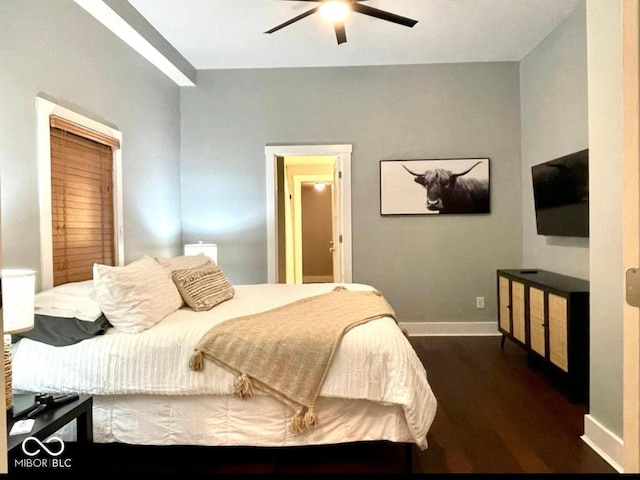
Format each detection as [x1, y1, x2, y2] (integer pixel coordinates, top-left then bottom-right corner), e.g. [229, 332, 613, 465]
[13, 284, 437, 448]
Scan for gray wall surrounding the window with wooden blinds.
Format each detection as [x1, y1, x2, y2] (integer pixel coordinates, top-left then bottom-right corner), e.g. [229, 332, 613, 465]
[0, 0, 181, 288]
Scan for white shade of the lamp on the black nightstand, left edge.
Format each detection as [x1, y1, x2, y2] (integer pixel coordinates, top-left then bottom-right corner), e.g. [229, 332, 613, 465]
[0, 268, 36, 333]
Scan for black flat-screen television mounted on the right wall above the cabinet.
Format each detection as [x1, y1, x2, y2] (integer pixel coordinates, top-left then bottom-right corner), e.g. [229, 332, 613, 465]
[531, 149, 589, 237]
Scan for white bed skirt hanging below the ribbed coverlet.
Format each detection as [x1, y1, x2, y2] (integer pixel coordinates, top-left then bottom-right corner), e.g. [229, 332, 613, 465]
[84, 395, 415, 447]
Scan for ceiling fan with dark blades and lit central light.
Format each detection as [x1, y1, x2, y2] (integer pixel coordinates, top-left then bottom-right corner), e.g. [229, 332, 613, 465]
[264, 0, 418, 45]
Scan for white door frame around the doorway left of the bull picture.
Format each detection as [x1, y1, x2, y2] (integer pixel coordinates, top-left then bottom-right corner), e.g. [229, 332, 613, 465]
[264, 145, 353, 283]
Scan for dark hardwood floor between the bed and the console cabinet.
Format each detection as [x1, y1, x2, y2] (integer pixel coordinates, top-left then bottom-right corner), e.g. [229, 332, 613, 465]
[412, 337, 617, 473]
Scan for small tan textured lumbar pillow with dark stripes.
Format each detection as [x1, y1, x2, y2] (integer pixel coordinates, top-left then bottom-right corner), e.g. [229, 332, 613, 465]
[171, 265, 235, 312]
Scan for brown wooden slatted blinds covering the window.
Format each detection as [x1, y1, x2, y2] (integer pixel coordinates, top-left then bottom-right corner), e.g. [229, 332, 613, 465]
[50, 124, 119, 286]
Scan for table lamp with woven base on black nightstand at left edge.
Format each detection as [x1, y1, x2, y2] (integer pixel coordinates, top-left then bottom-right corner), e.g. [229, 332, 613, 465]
[0, 268, 36, 410]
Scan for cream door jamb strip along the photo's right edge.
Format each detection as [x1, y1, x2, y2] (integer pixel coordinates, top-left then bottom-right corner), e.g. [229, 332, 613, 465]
[622, 0, 640, 473]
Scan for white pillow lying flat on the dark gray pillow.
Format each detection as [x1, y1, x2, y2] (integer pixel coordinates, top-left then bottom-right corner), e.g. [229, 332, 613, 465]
[34, 280, 102, 322]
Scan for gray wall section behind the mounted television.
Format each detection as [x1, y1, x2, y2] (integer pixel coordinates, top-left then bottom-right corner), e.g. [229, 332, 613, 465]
[520, 5, 589, 279]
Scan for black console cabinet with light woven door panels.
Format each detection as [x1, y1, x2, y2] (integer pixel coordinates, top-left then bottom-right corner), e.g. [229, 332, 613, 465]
[497, 269, 589, 403]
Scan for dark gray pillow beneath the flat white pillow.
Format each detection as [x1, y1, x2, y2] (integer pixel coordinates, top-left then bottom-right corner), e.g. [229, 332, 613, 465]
[11, 314, 111, 347]
